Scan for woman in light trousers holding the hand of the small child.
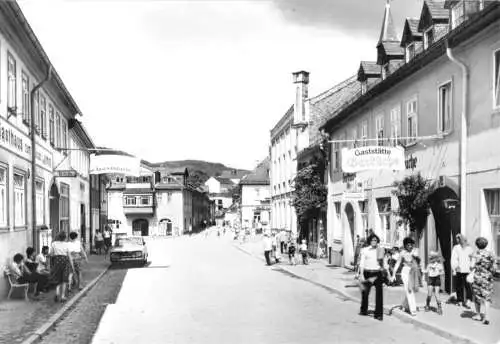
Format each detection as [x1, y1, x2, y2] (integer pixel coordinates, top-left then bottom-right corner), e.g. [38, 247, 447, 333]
[391, 237, 420, 316]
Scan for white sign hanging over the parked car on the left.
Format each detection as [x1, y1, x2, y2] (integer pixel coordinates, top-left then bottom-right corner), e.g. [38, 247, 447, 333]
[90, 154, 141, 177]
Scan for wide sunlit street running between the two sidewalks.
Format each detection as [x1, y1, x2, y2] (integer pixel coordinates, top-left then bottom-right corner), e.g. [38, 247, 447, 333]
[37, 235, 450, 344]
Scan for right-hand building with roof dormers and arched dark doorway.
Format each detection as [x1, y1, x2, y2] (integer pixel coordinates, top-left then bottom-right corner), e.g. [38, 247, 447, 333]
[322, 1, 500, 291]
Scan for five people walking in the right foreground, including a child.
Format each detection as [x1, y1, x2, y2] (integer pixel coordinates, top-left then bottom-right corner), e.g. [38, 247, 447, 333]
[359, 234, 495, 325]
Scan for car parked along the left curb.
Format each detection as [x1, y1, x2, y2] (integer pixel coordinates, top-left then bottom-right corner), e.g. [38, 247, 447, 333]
[109, 236, 148, 265]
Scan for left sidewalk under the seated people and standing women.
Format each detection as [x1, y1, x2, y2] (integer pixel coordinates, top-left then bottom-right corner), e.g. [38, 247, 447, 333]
[0, 255, 109, 344]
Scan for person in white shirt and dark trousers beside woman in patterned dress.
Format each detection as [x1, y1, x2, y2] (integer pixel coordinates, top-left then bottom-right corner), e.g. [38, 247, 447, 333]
[451, 234, 474, 308]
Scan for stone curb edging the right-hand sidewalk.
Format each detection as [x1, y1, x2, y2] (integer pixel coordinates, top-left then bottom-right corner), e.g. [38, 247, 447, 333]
[234, 245, 484, 344]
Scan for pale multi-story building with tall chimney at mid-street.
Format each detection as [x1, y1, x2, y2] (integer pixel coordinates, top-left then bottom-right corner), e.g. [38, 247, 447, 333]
[269, 71, 309, 235]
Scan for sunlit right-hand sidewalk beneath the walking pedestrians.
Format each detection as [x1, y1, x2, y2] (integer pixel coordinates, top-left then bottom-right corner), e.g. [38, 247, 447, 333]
[235, 238, 500, 344]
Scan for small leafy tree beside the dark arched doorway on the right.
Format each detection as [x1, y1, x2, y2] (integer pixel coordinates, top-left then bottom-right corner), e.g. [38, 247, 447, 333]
[392, 173, 435, 238]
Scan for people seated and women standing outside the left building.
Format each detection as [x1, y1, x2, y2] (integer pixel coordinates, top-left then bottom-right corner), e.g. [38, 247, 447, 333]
[8, 232, 88, 302]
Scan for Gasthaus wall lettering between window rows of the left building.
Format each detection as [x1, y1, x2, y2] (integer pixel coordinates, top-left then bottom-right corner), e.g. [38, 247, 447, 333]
[0, 117, 52, 170]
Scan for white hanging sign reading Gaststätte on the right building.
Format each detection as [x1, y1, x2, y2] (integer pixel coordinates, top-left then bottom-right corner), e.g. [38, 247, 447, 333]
[342, 146, 405, 173]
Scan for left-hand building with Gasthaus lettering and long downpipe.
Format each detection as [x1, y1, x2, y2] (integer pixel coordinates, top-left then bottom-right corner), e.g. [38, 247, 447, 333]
[0, 1, 98, 295]
